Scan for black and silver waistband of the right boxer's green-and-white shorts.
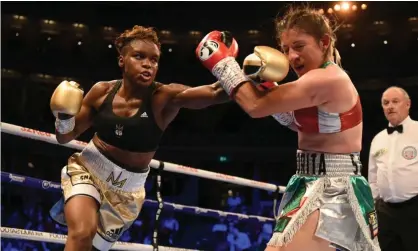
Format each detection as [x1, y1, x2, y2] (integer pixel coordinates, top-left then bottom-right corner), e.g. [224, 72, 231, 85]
[296, 150, 362, 177]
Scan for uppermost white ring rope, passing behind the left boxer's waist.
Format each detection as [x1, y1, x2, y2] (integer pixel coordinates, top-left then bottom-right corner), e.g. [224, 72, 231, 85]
[1, 122, 285, 193]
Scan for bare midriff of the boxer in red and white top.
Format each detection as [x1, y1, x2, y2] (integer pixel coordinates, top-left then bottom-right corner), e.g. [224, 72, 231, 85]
[298, 123, 363, 153]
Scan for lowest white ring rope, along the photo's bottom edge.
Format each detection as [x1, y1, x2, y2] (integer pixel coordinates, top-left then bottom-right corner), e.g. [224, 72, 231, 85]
[1, 227, 198, 251]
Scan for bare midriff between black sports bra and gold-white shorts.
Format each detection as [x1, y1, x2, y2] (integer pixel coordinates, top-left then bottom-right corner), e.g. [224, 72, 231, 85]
[93, 135, 155, 173]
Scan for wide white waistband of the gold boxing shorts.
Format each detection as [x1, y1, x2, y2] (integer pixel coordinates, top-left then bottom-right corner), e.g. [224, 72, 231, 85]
[80, 141, 150, 192]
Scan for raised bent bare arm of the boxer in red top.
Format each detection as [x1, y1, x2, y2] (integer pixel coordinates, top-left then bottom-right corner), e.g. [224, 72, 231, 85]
[230, 69, 348, 118]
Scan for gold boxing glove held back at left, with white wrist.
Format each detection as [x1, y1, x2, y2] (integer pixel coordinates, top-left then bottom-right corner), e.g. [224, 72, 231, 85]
[50, 80, 84, 134]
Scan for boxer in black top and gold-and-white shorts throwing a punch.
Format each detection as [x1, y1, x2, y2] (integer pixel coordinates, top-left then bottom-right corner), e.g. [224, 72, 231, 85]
[51, 26, 238, 251]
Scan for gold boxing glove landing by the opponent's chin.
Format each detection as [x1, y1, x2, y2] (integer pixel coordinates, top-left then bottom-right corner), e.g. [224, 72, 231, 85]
[242, 46, 289, 84]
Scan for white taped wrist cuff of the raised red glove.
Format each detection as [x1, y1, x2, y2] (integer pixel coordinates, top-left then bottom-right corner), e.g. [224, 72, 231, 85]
[212, 57, 249, 96]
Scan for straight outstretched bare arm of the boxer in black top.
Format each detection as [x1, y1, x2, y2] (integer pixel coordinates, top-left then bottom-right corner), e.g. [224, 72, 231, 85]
[170, 82, 230, 109]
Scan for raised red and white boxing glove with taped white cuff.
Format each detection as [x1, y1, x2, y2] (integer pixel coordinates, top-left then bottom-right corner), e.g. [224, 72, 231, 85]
[196, 31, 249, 95]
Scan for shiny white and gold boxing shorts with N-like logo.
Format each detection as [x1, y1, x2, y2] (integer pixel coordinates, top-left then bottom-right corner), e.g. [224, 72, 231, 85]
[51, 141, 149, 250]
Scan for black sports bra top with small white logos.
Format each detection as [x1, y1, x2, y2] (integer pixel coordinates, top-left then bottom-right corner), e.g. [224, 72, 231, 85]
[93, 80, 164, 152]
